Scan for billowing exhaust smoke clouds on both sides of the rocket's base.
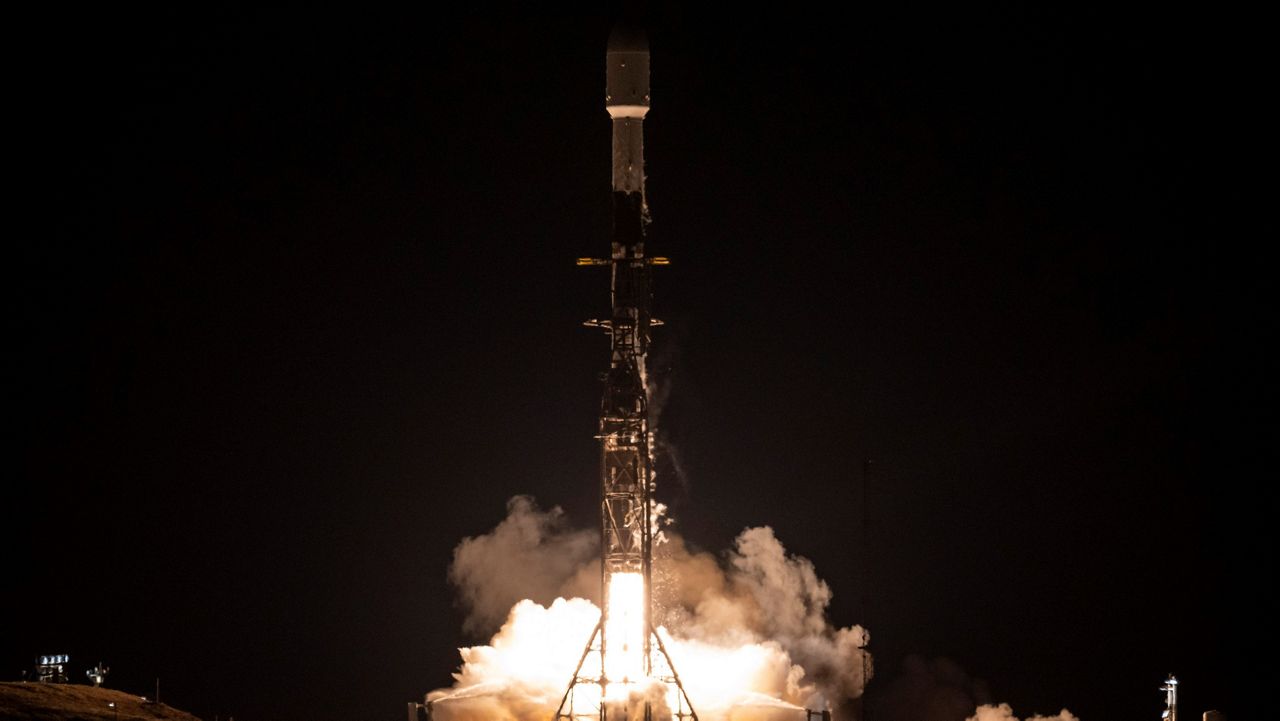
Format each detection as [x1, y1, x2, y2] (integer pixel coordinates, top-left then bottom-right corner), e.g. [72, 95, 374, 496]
[428, 496, 875, 721]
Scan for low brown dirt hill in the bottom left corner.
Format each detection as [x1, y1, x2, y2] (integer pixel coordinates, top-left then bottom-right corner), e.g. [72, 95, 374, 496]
[0, 683, 200, 721]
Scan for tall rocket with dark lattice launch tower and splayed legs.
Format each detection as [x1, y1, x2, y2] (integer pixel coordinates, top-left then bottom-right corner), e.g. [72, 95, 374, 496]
[556, 22, 698, 721]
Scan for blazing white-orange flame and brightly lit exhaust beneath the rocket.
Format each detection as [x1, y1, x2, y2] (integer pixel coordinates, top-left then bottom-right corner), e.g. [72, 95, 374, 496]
[430, 594, 814, 721]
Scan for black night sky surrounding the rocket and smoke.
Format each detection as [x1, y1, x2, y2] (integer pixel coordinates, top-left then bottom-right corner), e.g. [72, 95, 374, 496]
[0, 4, 1259, 721]
